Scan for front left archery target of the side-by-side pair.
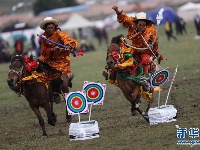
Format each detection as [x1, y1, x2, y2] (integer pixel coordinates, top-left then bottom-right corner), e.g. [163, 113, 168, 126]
[66, 91, 88, 115]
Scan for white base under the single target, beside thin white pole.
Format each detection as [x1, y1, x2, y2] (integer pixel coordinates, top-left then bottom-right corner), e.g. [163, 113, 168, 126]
[148, 105, 177, 125]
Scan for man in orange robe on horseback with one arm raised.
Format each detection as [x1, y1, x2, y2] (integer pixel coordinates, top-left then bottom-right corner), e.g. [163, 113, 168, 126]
[112, 6, 163, 91]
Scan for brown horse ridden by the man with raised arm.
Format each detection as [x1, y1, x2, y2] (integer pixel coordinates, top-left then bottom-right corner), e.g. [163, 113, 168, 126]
[103, 35, 153, 121]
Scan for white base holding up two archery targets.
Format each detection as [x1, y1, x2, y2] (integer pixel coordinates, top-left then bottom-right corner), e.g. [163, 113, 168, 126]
[69, 120, 99, 141]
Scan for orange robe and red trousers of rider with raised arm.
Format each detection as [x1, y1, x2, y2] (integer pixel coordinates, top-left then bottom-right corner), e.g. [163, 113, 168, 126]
[117, 13, 158, 74]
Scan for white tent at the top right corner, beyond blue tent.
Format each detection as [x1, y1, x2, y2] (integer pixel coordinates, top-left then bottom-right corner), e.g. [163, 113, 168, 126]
[177, 2, 200, 21]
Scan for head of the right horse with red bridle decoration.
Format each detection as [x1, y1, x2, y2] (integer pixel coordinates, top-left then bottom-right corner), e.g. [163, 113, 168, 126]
[106, 34, 124, 69]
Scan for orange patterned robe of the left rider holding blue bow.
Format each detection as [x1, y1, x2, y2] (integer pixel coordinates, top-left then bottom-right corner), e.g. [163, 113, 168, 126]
[39, 30, 78, 74]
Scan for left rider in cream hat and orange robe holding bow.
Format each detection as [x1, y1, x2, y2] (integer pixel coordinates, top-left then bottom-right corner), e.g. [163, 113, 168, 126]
[39, 17, 78, 103]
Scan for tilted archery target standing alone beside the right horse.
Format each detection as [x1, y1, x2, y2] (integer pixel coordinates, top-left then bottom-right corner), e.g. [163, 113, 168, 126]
[151, 68, 169, 87]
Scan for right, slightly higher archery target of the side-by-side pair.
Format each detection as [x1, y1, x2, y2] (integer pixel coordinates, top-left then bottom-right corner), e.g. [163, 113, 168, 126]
[83, 81, 106, 105]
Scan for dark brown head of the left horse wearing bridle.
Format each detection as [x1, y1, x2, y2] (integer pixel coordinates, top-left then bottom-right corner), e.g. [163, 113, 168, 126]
[7, 55, 24, 93]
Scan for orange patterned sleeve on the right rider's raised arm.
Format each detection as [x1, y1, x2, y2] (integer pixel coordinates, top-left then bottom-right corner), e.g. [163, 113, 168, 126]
[117, 12, 135, 28]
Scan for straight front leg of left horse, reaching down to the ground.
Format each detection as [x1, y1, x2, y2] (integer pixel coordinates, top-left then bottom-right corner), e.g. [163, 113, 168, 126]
[30, 106, 48, 139]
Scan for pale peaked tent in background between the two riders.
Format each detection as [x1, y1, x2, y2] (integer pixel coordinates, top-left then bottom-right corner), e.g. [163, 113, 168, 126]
[61, 13, 94, 30]
